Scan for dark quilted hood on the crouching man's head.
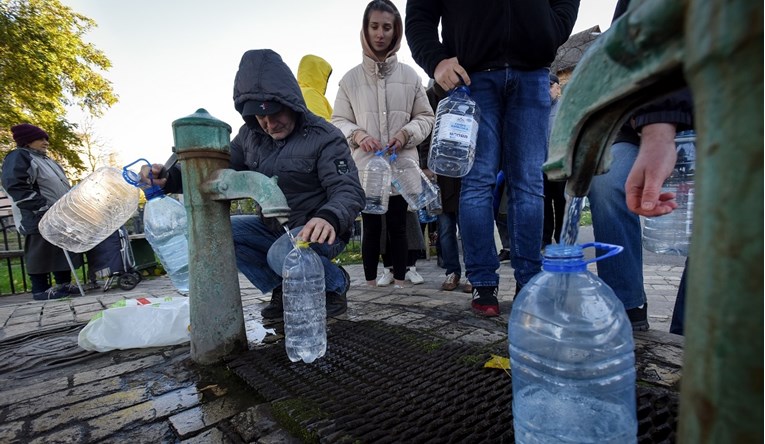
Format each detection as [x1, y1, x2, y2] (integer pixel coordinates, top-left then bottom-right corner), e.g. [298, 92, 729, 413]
[234, 49, 307, 115]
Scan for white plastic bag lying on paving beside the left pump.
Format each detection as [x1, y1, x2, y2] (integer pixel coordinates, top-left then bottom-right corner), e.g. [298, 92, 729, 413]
[77, 297, 190, 352]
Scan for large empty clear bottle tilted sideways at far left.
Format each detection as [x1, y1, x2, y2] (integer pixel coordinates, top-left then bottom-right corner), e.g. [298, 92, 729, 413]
[39, 167, 139, 253]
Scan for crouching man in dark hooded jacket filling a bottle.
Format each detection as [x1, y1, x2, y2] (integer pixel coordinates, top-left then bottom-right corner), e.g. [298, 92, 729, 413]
[141, 49, 365, 319]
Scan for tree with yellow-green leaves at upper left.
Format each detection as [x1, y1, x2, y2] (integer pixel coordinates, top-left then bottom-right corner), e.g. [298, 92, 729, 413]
[0, 0, 117, 171]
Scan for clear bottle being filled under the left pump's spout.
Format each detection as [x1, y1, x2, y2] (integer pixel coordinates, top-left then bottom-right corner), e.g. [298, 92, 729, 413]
[282, 240, 327, 364]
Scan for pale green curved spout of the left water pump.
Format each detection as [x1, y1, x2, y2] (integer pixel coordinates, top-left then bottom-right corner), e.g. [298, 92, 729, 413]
[201, 169, 290, 225]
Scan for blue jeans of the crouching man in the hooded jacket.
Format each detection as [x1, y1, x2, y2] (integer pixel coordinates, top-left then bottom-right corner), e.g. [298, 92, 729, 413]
[231, 215, 345, 293]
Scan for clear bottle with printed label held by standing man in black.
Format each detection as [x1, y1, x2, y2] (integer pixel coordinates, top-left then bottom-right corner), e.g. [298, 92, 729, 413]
[428, 86, 481, 177]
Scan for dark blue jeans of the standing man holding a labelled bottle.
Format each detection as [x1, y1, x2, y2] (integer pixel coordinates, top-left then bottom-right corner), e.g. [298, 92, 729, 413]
[460, 68, 550, 287]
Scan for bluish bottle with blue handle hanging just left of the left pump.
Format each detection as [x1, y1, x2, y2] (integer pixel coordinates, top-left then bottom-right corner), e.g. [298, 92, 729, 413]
[122, 159, 189, 294]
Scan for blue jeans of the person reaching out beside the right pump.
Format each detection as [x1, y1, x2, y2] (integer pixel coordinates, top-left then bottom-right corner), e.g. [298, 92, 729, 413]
[588, 143, 646, 310]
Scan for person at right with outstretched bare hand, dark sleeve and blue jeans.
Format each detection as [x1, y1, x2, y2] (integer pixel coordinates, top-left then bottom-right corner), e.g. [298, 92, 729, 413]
[587, 0, 693, 332]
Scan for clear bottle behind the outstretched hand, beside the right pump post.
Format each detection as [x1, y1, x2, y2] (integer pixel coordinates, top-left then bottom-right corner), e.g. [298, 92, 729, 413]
[643, 131, 696, 256]
